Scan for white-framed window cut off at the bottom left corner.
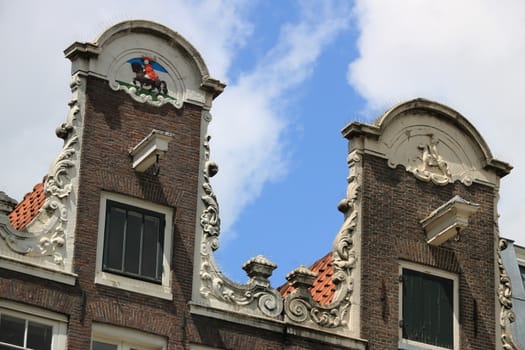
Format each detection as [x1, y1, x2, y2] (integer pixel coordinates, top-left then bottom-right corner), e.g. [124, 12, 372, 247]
[0, 301, 67, 350]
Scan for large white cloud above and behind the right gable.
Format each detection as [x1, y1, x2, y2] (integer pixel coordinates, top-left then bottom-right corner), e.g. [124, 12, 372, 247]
[349, 0, 525, 244]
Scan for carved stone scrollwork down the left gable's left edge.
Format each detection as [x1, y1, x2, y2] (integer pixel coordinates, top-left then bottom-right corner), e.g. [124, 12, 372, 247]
[0, 75, 80, 267]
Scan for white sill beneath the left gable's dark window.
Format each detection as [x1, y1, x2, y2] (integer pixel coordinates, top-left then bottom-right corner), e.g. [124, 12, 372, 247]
[95, 271, 173, 300]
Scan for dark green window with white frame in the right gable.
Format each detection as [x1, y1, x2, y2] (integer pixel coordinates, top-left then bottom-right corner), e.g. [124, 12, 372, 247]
[400, 266, 458, 349]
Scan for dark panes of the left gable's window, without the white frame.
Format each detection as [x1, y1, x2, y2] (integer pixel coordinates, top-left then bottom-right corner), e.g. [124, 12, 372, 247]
[103, 200, 165, 283]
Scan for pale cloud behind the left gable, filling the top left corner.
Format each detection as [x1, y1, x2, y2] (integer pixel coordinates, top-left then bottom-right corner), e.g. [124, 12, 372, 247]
[0, 0, 251, 200]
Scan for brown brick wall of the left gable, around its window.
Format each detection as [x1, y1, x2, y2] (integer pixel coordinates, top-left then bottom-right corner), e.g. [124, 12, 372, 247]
[69, 78, 201, 349]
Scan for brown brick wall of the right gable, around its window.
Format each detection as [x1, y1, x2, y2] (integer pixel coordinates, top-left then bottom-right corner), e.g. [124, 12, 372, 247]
[361, 155, 496, 350]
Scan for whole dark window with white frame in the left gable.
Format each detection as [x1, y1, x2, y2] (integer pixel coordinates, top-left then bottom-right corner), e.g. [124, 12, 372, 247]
[95, 192, 173, 300]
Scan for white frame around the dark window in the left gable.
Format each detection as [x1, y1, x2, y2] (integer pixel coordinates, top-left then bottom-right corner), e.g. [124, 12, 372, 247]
[95, 192, 173, 300]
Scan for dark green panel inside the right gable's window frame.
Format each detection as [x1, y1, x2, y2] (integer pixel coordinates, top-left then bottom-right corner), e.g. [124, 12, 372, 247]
[403, 269, 453, 348]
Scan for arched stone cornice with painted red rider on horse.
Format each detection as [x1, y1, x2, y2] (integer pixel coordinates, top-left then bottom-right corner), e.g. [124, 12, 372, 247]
[64, 20, 225, 108]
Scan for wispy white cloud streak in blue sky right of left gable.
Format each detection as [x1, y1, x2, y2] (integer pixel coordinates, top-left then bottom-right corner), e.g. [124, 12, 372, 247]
[210, 3, 350, 242]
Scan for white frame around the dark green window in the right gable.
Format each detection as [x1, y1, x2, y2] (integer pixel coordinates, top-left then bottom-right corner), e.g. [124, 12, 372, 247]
[398, 261, 459, 350]
